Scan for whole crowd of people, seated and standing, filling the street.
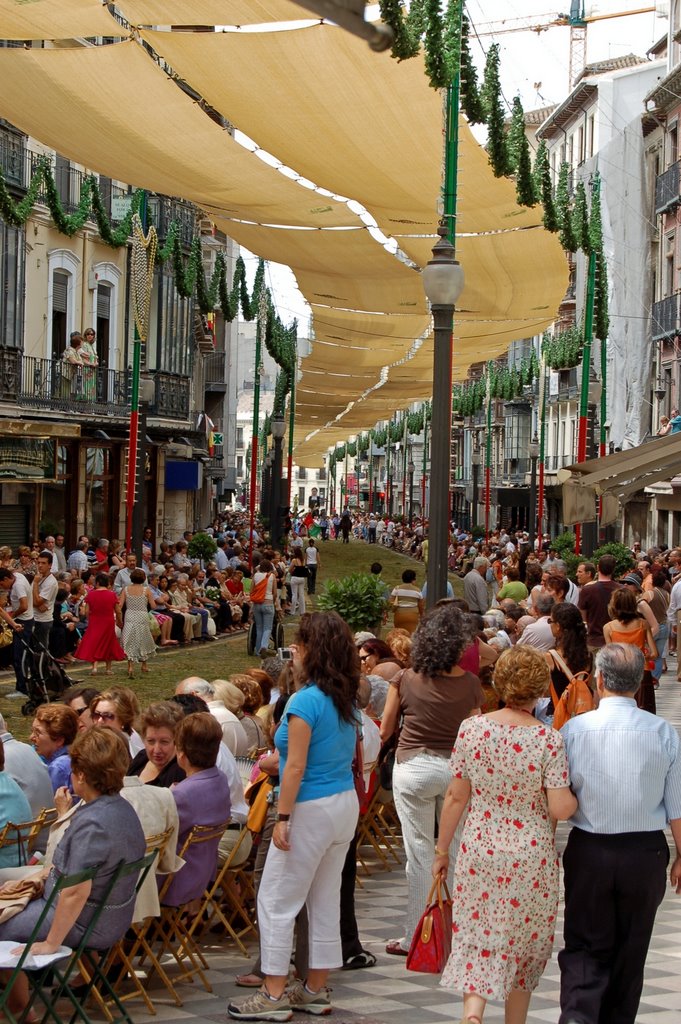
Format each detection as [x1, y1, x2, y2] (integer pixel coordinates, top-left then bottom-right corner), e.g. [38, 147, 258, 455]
[0, 510, 681, 1024]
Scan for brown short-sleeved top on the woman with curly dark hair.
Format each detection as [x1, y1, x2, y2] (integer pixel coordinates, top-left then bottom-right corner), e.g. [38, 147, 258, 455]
[390, 669, 484, 764]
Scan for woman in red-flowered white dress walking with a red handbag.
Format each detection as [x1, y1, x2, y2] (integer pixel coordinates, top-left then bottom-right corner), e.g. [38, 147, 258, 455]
[432, 646, 577, 1024]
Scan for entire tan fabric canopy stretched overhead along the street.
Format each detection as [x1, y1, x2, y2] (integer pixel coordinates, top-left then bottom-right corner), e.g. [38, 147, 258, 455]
[0, 12, 567, 456]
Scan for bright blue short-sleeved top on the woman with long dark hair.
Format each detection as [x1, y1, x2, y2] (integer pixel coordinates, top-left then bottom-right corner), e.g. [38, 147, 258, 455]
[274, 683, 357, 803]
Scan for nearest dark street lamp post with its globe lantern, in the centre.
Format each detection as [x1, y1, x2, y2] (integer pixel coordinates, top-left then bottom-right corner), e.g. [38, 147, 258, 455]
[421, 221, 464, 608]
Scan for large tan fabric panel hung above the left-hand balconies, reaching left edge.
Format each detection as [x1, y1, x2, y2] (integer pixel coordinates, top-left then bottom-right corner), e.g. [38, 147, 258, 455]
[0, 40, 356, 226]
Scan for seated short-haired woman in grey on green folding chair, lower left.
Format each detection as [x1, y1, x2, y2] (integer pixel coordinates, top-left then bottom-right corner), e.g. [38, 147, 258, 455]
[0, 727, 145, 1016]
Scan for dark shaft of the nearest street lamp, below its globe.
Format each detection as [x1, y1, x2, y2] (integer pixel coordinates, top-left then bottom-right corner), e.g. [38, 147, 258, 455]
[426, 305, 454, 608]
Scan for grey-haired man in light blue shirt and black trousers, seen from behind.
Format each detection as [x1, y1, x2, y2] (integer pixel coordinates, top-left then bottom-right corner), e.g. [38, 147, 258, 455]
[558, 643, 681, 1024]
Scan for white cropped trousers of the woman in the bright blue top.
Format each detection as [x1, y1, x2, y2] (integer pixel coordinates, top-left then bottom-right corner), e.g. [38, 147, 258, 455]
[258, 790, 359, 976]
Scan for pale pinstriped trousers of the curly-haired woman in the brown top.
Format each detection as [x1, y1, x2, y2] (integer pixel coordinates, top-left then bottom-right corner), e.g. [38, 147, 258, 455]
[392, 754, 463, 949]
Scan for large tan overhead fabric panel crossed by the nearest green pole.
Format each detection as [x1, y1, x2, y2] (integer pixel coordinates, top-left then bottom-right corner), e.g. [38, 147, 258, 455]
[142, 23, 542, 234]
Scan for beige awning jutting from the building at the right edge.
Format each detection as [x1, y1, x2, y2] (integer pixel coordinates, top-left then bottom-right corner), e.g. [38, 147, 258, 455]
[557, 433, 681, 524]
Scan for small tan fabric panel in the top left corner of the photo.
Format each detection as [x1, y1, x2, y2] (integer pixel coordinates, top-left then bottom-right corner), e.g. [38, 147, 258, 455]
[0, 0, 118, 39]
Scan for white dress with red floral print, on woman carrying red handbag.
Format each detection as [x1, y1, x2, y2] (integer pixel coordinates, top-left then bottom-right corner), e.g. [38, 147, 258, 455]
[440, 717, 569, 999]
